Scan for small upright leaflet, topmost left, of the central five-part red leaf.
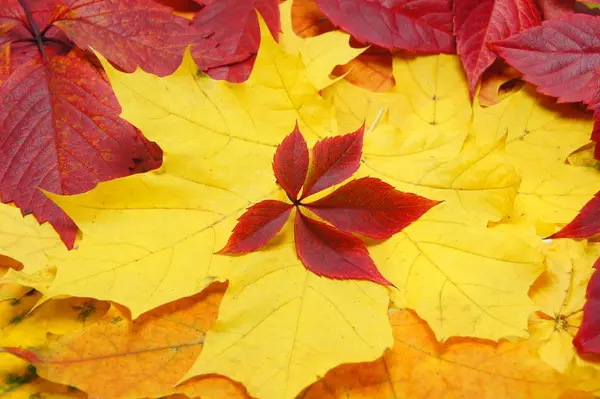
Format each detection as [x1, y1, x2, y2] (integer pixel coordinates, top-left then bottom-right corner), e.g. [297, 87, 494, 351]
[273, 124, 308, 201]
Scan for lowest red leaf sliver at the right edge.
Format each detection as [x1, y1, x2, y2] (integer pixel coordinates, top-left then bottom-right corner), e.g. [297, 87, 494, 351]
[573, 259, 600, 355]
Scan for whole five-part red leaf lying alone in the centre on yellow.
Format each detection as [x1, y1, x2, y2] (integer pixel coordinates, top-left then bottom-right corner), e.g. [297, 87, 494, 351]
[218, 126, 439, 285]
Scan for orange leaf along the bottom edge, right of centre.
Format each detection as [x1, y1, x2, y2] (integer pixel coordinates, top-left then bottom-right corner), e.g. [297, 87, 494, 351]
[300, 310, 575, 399]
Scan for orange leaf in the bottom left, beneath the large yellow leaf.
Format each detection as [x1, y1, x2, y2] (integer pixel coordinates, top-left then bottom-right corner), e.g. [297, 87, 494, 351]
[32, 285, 232, 399]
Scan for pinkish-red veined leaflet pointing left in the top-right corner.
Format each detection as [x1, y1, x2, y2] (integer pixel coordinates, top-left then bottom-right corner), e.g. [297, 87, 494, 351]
[491, 14, 600, 104]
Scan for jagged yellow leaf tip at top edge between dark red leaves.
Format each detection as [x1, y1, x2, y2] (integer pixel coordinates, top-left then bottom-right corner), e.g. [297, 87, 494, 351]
[279, 0, 366, 90]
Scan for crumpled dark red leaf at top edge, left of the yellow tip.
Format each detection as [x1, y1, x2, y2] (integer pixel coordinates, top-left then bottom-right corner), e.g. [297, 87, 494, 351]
[192, 0, 281, 83]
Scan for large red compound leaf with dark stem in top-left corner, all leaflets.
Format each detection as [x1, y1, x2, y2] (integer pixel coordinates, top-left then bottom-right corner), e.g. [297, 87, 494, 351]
[0, 0, 190, 248]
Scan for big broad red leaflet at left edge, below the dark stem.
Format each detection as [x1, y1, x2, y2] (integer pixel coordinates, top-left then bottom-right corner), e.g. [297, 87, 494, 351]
[0, 50, 137, 248]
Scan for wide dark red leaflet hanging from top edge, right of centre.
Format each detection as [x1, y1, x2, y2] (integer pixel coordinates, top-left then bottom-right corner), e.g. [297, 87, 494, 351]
[316, 0, 455, 54]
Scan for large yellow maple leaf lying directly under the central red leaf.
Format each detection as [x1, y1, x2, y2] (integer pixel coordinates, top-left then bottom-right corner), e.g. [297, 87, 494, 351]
[39, 18, 391, 399]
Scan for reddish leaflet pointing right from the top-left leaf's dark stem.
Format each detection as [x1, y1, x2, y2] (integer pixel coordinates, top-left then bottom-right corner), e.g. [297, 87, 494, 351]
[52, 0, 191, 76]
